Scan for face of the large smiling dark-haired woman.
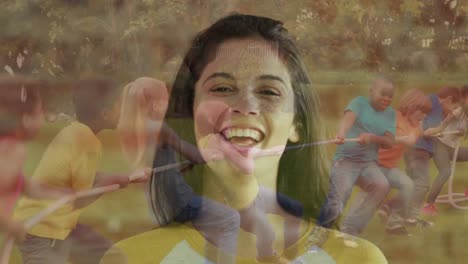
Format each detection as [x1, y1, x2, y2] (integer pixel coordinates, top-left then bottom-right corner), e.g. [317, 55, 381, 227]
[194, 39, 298, 174]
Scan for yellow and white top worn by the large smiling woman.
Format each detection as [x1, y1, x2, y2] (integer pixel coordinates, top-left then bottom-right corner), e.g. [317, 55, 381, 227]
[101, 219, 387, 264]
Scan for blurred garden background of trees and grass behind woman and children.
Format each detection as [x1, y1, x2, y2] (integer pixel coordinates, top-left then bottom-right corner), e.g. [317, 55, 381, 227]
[0, 0, 468, 264]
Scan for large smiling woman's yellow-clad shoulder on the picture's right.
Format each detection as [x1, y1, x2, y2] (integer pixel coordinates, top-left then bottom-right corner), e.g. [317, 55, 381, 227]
[322, 229, 388, 264]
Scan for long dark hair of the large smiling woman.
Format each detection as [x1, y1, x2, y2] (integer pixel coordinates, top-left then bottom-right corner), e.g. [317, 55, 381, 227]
[150, 14, 327, 225]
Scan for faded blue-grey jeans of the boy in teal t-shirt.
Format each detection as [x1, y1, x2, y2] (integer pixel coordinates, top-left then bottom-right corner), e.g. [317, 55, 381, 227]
[319, 159, 390, 235]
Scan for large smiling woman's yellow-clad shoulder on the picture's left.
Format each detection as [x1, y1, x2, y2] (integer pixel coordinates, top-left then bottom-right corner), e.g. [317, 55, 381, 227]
[101, 225, 201, 264]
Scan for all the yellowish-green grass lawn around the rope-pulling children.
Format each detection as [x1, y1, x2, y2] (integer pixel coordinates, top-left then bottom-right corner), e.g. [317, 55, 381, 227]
[6, 72, 468, 264]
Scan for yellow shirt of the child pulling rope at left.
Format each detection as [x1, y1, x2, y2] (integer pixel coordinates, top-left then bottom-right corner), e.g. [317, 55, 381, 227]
[15, 122, 102, 240]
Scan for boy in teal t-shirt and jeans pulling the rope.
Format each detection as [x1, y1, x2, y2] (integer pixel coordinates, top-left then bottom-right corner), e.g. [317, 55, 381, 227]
[319, 76, 396, 235]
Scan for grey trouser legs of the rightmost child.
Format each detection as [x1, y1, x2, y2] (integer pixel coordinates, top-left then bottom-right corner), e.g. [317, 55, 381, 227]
[426, 140, 468, 203]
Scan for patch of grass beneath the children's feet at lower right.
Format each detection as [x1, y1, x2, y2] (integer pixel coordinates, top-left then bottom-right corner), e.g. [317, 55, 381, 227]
[362, 164, 468, 264]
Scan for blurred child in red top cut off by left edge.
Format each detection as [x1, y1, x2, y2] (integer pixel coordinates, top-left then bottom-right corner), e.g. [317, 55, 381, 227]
[0, 77, 65, 245]
